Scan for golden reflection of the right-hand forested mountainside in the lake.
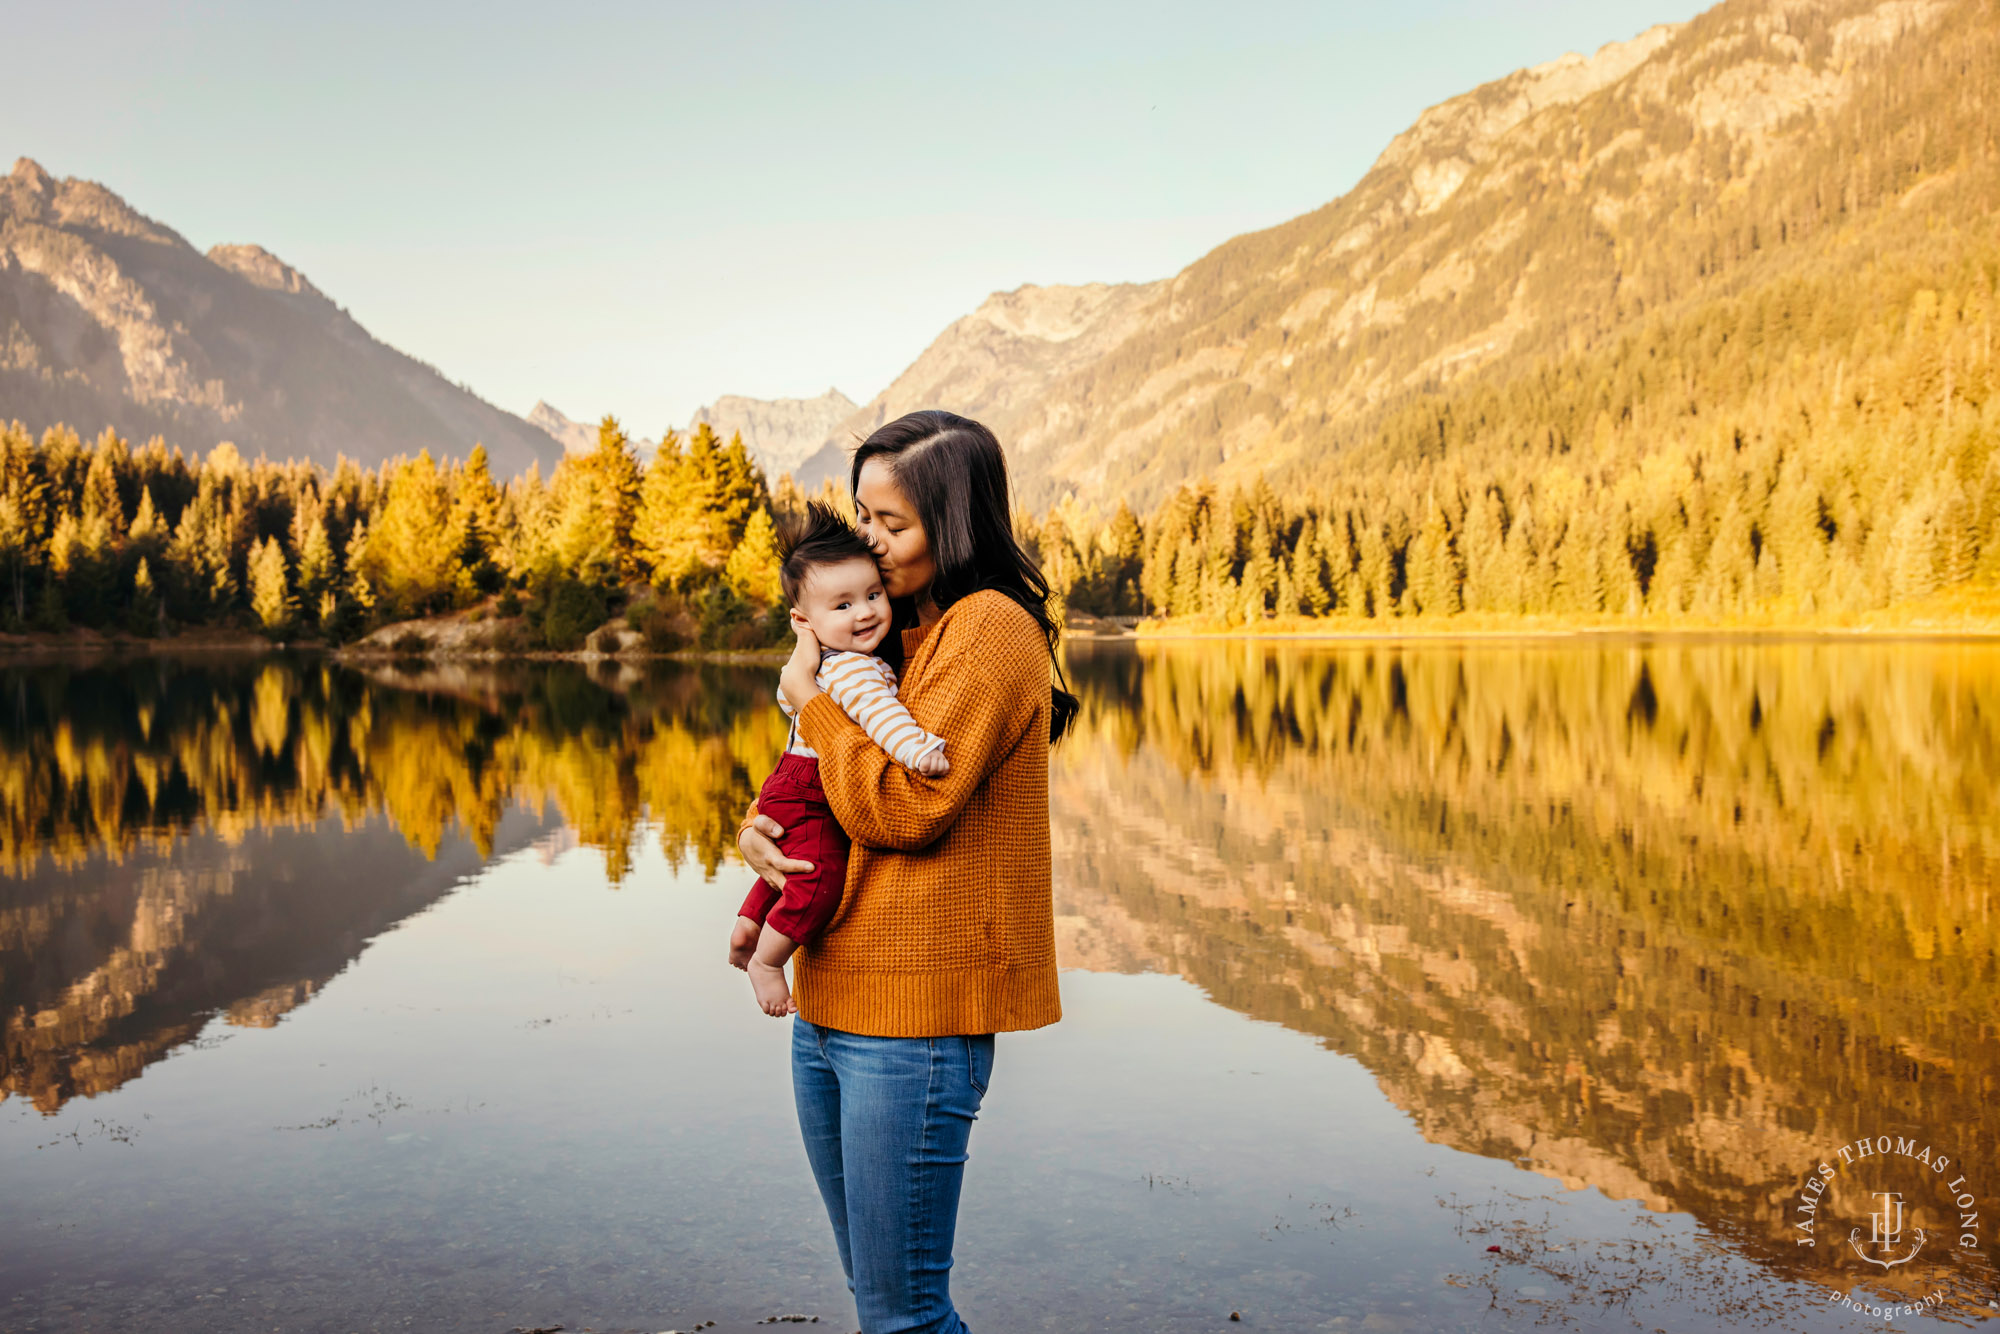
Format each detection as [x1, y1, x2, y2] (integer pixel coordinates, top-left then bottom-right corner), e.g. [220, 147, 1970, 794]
[1052, 646, 2000, 1296]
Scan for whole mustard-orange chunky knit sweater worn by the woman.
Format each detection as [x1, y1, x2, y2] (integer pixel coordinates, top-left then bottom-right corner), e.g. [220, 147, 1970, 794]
[792, 590, 1062, 1038]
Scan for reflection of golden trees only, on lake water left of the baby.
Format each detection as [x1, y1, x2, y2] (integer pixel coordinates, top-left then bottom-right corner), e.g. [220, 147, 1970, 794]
[0, 658, 784, 880]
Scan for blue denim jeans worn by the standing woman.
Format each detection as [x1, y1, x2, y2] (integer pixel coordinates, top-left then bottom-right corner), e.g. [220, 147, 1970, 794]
[792, 1020, 994, 1334]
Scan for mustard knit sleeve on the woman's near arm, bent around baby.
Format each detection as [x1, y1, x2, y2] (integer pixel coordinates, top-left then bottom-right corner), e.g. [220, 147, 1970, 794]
[798, 592, 1048, 850]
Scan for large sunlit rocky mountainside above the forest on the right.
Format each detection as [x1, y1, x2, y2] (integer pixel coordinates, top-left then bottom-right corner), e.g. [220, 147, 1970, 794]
[848, 0, 1968, 508]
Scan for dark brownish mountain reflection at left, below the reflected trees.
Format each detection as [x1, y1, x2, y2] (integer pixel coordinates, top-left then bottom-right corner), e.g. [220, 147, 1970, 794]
[0, 812, 546, 1112]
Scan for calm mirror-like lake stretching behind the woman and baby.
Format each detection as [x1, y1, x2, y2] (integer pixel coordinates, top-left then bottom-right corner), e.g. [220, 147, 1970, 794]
[0, 638, 2000, 1334]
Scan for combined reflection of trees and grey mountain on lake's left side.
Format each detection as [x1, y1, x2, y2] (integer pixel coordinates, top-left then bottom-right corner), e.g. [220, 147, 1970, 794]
[0, 658, 784, 1110]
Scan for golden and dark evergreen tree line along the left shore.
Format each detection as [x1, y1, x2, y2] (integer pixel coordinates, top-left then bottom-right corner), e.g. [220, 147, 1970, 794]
[0, 416, 804, 648]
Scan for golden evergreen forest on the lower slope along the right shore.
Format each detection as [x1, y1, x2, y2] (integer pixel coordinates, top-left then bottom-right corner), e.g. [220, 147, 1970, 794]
[1034, 246, 2000, 624]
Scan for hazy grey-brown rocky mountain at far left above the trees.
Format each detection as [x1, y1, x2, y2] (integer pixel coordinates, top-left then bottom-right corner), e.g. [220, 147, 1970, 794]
[0, 158, 560, 476]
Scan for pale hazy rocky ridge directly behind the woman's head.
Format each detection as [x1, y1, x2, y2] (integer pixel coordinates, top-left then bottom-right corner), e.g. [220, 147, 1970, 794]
[788, 282, 1166, 490]
